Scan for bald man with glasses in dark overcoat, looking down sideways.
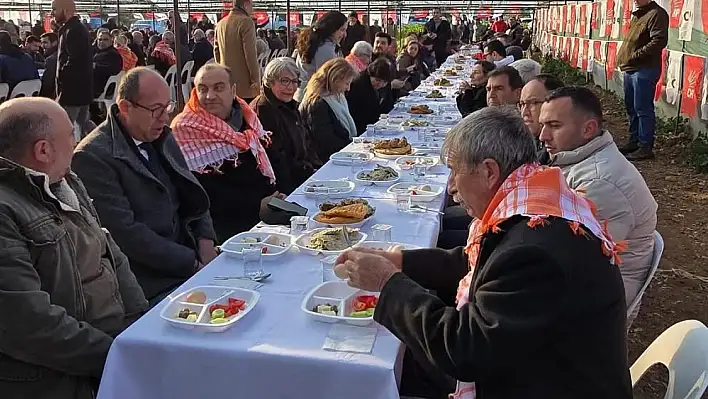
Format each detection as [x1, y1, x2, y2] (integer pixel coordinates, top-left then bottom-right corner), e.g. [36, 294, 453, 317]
[71, 67, 216, 305]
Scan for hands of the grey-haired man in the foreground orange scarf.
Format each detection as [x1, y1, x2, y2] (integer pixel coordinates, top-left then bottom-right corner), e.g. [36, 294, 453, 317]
[334, 249, 401, 292]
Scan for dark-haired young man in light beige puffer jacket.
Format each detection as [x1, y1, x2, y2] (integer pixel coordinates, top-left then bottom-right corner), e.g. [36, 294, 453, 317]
[539, 86, 657, 323]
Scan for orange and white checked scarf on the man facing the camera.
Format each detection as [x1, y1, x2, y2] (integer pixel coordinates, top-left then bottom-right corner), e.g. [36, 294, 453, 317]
[171, 88, 275, 183]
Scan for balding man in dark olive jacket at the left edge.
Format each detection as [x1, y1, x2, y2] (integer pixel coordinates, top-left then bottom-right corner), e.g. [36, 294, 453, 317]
[0, 98, 148, 399]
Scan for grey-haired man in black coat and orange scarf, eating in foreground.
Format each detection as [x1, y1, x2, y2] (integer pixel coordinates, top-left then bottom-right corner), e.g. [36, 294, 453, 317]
[335, 107, 632, 399]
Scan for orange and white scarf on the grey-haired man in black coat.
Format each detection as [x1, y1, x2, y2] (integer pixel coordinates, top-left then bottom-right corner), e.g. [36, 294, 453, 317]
[450, 164, 624, 399]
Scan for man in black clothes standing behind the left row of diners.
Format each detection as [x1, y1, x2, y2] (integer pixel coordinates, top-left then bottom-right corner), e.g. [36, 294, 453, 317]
[52, 0, 93, 141]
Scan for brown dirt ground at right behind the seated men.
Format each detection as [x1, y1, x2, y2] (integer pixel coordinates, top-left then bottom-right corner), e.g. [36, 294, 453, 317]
[596, 88, 708, 399]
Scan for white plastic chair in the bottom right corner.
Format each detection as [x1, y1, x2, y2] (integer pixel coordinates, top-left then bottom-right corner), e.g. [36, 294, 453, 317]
[629, 320, 708, 399]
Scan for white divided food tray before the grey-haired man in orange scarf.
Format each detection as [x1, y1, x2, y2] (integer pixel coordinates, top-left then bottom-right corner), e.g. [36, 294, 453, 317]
[301, 280, 379, 326]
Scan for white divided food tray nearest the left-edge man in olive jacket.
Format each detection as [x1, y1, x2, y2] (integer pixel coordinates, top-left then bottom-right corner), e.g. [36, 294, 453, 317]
[160, 286, 261, 332]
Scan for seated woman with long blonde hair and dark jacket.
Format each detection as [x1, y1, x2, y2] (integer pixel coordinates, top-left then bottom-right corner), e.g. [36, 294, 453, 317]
[300, 58, 357, 161]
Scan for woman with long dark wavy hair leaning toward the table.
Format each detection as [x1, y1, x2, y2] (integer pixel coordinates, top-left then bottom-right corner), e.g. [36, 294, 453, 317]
[295, 11, 348, 101]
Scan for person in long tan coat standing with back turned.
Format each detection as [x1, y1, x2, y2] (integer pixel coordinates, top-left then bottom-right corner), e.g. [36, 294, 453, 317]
[214, 0, 261, 104]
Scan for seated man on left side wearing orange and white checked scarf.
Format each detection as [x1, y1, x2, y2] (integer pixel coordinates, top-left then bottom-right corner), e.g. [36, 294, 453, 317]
[172, 63, 284, 242]
